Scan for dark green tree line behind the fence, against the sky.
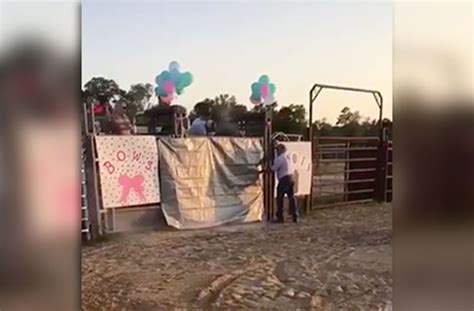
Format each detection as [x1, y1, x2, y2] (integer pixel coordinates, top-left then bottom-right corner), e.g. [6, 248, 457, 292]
[82, 77, 392, 137]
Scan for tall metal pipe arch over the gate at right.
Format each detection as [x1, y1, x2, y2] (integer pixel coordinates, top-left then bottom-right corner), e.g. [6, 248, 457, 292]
[306, 83, 383, 209]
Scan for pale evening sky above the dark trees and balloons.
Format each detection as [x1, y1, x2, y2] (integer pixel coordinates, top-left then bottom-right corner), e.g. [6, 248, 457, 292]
[0, 0, 392, 125]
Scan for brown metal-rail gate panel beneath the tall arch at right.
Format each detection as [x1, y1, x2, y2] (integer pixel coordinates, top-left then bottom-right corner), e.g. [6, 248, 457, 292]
[312, 137, 393, 208]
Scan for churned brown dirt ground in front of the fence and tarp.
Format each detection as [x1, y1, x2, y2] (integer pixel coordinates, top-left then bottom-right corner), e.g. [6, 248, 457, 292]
[82, 204, 392, 310]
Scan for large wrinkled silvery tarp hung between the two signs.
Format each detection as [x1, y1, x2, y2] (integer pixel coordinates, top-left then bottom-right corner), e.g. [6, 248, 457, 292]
[158, 137, 263, 229]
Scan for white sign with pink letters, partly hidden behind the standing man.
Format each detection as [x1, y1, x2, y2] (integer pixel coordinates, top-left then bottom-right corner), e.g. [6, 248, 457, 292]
[275, 141, 312, 196]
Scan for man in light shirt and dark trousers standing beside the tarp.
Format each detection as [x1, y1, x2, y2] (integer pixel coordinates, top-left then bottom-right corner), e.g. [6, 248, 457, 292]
[271, 144, 298, 222]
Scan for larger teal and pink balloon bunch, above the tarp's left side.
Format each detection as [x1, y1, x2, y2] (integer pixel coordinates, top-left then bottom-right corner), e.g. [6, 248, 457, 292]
[155, 62, 193, 104]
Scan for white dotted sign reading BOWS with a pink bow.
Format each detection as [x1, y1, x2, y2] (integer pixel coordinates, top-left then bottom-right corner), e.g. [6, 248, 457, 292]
[96, 136, 160, 208]
